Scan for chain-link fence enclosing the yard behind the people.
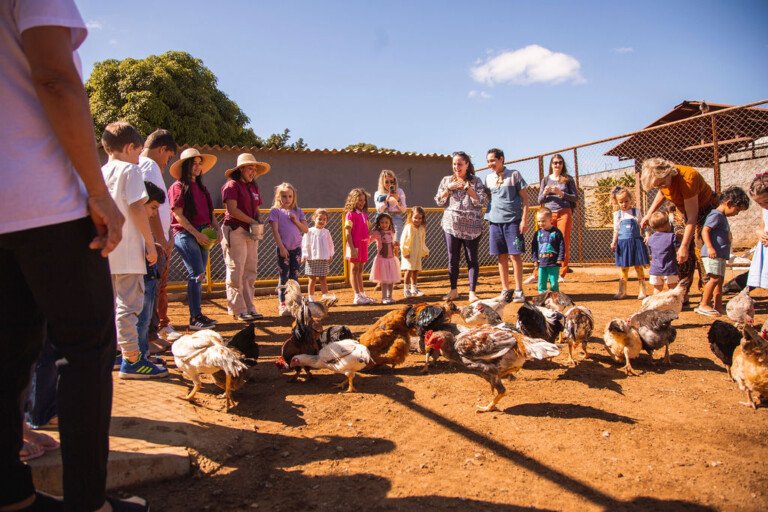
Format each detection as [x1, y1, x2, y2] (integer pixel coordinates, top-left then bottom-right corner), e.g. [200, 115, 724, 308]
[169, 100, 768, 290]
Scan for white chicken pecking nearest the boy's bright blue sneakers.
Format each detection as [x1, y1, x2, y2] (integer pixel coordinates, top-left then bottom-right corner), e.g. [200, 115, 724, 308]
[171, 329, 248, 410]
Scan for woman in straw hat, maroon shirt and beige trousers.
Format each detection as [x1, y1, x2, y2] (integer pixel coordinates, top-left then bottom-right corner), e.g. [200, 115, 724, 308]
[221, 153, 270, 322]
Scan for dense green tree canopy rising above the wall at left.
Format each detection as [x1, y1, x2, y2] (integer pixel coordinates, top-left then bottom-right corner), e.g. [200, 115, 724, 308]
[85, 51, 306, 149]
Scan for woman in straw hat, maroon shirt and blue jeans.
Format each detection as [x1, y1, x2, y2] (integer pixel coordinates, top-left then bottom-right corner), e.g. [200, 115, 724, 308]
[168, 148, 221, 331]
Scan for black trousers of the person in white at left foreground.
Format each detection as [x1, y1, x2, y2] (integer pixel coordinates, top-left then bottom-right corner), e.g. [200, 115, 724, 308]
[0, 217, 117, 510]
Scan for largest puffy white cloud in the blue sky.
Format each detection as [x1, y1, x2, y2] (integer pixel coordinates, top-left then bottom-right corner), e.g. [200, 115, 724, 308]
[470, 44, 585, 85]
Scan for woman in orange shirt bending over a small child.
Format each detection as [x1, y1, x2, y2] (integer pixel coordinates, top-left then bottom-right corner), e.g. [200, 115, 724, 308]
[640, 158, 716, 300]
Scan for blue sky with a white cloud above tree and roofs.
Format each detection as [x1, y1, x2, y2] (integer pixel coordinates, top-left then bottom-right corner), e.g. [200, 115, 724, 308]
[77, 0, 768, 163]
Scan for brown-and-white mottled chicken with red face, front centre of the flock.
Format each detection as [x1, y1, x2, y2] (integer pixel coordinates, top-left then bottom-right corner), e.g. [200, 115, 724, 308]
[424, 325, 560, 412]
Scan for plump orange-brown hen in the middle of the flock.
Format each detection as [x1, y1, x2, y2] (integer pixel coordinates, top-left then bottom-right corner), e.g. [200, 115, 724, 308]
[359, 301, 457, 368]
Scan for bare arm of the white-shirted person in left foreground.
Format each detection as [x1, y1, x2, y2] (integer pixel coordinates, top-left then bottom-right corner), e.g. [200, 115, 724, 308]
[21, 26, 125, 256]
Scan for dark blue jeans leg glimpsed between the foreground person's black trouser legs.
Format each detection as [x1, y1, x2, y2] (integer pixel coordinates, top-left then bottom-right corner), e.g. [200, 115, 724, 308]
[24, 337, 59, 428]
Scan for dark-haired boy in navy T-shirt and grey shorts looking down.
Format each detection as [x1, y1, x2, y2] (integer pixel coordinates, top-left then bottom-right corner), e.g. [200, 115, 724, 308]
[694, 187, 749, 316]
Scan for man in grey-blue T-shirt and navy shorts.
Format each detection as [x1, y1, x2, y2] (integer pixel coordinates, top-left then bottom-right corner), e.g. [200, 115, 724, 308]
[485, 148, 528, 302]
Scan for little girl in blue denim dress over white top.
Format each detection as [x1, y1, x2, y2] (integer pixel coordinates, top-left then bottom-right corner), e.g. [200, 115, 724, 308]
[611, 186, 648, 300]
